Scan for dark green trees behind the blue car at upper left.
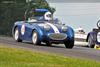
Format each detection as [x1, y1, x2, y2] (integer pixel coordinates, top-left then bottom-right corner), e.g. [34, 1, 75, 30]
[0, 0, 55, 36]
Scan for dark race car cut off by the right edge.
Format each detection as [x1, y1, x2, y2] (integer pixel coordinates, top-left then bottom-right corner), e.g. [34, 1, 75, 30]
[86, 20, 100, 49]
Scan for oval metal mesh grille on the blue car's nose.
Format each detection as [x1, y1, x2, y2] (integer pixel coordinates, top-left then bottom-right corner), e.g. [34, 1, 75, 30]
[49, 33, 67, 40]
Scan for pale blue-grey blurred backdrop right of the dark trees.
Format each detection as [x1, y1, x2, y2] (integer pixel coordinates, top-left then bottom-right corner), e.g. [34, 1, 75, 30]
[47, 2, 100, 33]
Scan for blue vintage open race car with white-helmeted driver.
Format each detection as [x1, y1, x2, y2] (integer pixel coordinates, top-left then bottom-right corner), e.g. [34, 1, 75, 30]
[12, 9, 74, 48]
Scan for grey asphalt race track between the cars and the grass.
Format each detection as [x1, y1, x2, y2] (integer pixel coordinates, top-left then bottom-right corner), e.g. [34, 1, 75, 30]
[0, 37, 100, 61]
